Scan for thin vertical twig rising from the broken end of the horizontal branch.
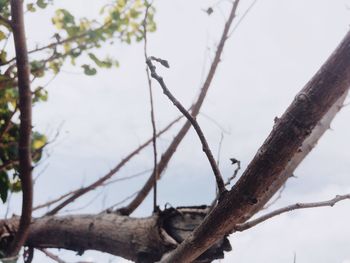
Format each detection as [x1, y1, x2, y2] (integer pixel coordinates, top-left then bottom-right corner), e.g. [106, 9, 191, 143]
[142, 1, 158, 212]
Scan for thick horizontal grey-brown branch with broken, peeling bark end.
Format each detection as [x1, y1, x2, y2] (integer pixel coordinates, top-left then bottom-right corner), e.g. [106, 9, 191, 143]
[0, 206, 231, 263]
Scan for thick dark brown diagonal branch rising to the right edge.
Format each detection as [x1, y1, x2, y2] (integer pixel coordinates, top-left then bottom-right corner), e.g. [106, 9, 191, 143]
[162, 32, 350, 263]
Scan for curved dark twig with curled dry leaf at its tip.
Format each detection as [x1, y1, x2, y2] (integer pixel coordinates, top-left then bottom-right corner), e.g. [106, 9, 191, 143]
[146, 57, 226, 195]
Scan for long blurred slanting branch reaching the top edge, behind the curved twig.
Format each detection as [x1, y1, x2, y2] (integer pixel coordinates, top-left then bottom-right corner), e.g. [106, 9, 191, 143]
[119, 0, 239, 215]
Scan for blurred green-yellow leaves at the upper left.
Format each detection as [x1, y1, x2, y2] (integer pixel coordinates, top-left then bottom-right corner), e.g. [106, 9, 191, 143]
[0, 0, 156, 202]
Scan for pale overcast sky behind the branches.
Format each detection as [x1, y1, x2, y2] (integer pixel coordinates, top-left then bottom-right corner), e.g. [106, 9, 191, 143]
[2, 0, 350, 263]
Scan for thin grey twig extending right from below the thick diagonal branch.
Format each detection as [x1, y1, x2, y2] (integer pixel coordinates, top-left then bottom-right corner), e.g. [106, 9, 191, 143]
[235, 194, 350, 232]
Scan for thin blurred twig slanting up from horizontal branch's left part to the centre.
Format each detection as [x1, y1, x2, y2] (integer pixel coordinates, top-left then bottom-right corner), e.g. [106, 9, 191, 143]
[47, 116, 182, 215]
